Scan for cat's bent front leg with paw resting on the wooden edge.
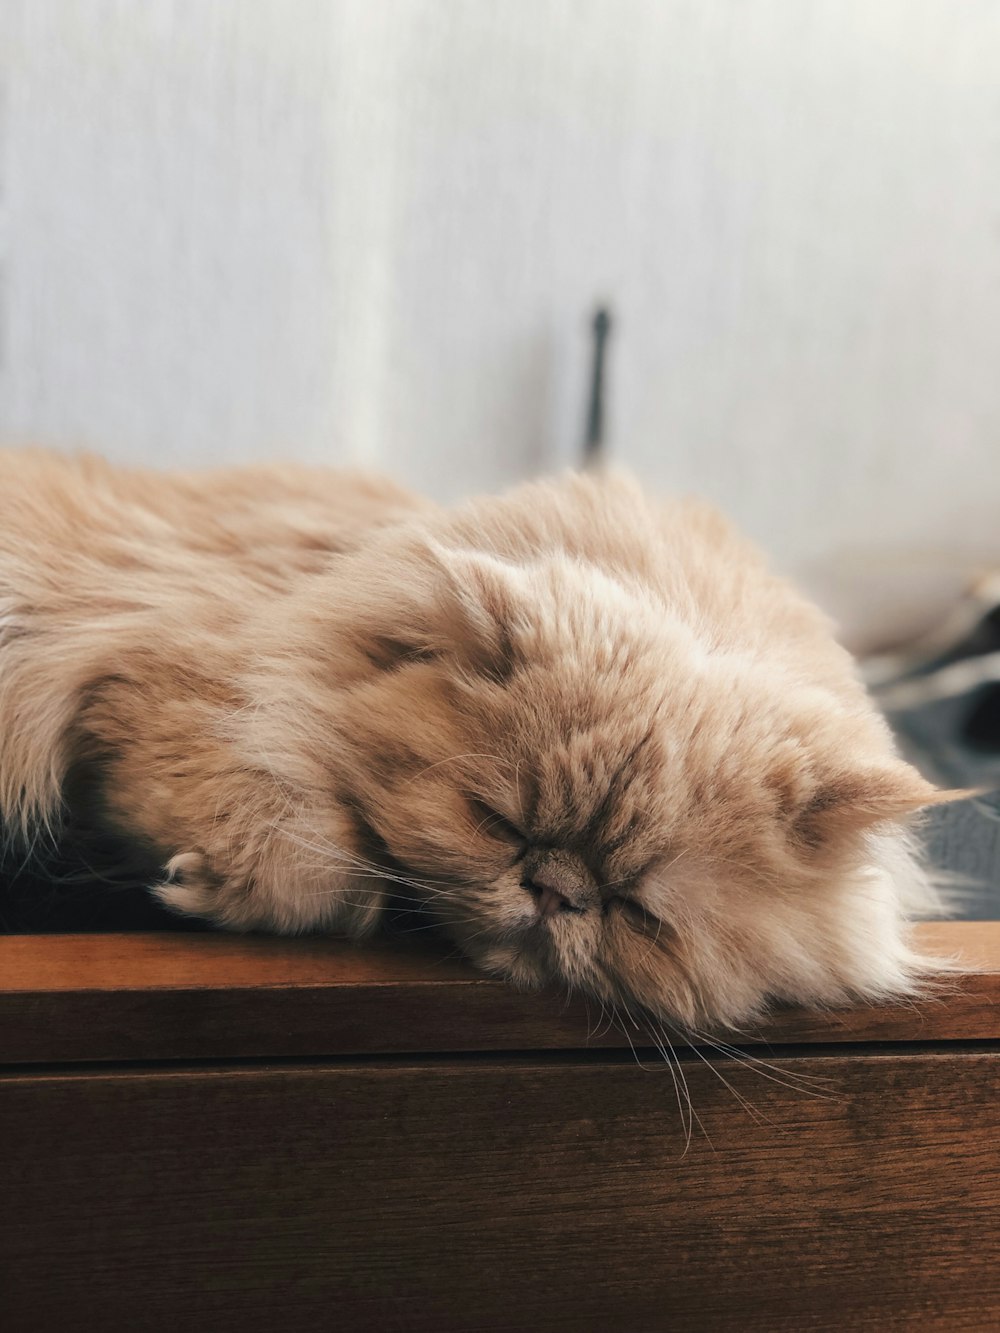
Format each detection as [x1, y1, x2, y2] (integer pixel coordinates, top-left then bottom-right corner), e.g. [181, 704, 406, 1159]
[57, 639, 385, 936]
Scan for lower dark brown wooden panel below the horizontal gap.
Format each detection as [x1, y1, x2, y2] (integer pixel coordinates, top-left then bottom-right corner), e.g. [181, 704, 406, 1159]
[0, 1052, 1000, 1333]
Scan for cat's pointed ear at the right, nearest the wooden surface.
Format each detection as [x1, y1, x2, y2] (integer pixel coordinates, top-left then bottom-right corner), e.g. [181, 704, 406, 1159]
[793, 761, 972, 846]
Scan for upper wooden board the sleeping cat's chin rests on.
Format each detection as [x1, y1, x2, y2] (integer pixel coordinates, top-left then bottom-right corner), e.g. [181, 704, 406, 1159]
[0, 922, 1000, 1064]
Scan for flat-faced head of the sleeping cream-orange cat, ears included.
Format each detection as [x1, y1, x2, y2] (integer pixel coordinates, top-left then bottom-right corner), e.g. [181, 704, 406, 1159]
[334, 541, 949, 1028]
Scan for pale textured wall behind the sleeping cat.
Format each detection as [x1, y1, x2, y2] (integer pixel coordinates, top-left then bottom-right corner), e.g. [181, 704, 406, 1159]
[0, 0, 1000, 618]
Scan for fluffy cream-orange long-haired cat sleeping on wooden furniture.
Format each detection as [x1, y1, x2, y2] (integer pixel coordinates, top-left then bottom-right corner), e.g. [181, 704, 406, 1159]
[0, 452, 951, 1028]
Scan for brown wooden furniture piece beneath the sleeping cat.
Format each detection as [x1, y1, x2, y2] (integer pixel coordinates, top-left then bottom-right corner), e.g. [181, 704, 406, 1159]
[0, 922, 1000, 1333]
